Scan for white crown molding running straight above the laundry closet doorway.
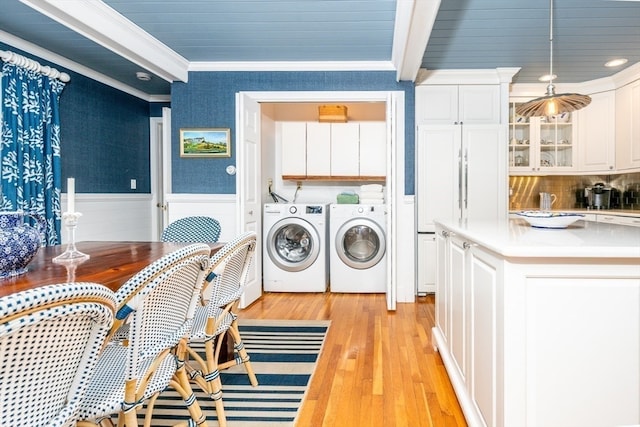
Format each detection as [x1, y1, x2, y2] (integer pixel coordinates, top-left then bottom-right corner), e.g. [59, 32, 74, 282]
[189, 61, 395, 71]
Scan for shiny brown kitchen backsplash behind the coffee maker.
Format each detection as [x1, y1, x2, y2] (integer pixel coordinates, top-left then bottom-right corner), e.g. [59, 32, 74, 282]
[509, 172, 640, 210]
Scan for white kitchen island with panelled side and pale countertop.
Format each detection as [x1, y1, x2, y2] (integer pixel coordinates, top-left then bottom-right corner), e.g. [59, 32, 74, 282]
[433, 219, 640, 427]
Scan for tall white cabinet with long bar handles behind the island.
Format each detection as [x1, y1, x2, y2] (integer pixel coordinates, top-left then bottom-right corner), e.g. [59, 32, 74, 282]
[416, 69, 516, 295]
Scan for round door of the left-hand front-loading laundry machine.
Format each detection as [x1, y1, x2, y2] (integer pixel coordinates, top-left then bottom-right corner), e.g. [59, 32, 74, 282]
[266, 217, 320, 271]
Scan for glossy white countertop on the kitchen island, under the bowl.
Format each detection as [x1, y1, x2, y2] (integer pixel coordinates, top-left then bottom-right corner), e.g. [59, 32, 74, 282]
[435, 219, 640, 260]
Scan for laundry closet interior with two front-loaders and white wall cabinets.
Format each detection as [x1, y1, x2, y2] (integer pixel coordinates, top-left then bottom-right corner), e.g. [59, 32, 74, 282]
[260, 102, 388, 293]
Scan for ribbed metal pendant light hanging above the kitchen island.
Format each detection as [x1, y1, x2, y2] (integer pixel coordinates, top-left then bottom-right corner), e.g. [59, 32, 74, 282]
[516, 0, 591, 117]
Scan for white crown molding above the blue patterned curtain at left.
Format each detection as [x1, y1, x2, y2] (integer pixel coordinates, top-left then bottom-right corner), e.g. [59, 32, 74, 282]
[0, 30, 159, 102]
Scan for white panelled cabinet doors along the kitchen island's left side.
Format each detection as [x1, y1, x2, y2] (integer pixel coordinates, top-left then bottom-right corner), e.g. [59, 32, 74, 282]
[434, 229, 502, 426]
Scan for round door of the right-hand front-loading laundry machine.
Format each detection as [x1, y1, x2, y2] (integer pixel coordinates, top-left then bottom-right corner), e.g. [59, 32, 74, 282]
[335, 218, 386, 270]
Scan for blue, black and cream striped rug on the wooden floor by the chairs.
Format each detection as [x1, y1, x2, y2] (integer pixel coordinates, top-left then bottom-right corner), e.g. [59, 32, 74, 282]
[139, 319, 330, 427]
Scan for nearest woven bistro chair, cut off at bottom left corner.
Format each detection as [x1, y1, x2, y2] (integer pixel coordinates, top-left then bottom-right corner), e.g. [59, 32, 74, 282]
[0, 282, 115, 427]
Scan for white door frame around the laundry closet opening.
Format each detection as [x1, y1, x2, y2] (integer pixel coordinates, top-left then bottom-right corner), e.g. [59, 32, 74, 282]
[236, 91, 413, 310]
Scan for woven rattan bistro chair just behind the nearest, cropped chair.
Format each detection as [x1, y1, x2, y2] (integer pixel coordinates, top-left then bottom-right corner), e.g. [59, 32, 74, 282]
[77, 244, 210, 427]
